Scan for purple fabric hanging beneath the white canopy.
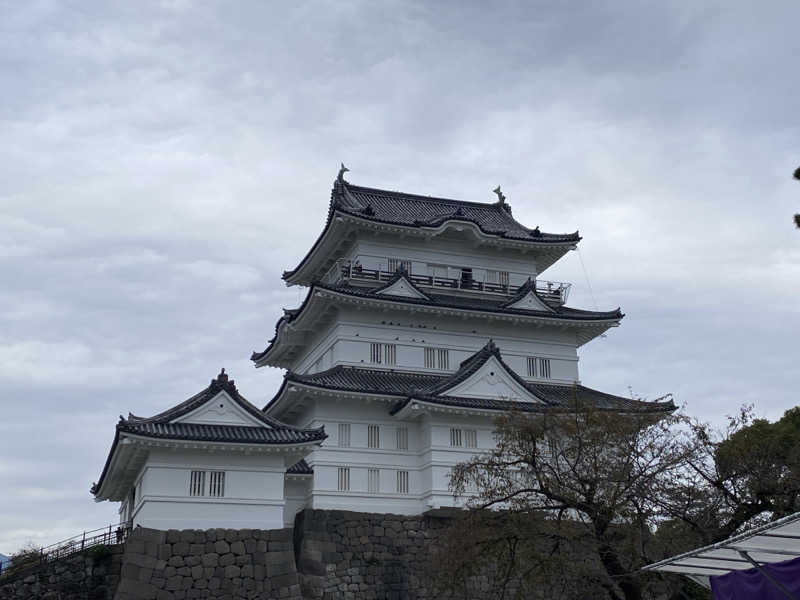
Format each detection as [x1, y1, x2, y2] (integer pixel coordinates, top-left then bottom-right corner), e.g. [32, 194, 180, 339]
[709, 558, 800, 600]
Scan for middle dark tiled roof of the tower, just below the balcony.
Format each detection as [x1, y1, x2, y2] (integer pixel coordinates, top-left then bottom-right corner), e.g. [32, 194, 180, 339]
[250, 275, 625, 361]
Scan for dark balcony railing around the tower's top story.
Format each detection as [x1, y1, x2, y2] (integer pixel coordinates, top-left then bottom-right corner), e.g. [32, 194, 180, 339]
[325, 261, 571, 305]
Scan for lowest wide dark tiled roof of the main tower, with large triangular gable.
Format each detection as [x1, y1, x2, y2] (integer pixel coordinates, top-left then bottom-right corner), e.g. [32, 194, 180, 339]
[274, 340, 675, 413]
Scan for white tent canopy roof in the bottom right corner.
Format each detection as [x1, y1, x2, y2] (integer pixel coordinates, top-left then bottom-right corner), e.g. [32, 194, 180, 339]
[644, 512, 800, 587]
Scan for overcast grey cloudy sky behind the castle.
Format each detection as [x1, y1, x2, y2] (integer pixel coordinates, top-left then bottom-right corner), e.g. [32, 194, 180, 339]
[0, 0, 800, 554]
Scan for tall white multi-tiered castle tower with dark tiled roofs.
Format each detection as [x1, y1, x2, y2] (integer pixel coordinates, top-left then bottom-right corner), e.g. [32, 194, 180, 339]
[252, 167, 674, 514]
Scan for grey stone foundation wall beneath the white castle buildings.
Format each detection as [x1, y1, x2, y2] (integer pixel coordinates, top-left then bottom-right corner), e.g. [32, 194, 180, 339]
[0, 510, 590, 600]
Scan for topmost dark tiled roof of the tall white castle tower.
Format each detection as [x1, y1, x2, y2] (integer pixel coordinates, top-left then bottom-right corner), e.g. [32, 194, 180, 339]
[332, 181, 580, 243]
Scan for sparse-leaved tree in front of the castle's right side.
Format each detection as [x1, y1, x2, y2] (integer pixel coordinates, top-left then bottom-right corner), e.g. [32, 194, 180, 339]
[444, 403, 697, 600]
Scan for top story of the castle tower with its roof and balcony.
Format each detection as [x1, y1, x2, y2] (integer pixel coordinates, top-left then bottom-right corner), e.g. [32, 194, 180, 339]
[283, 165, 581, 304]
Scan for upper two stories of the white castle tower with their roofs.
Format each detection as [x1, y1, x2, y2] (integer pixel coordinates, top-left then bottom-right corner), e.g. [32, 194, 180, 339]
[252, 167, 623, 384]
